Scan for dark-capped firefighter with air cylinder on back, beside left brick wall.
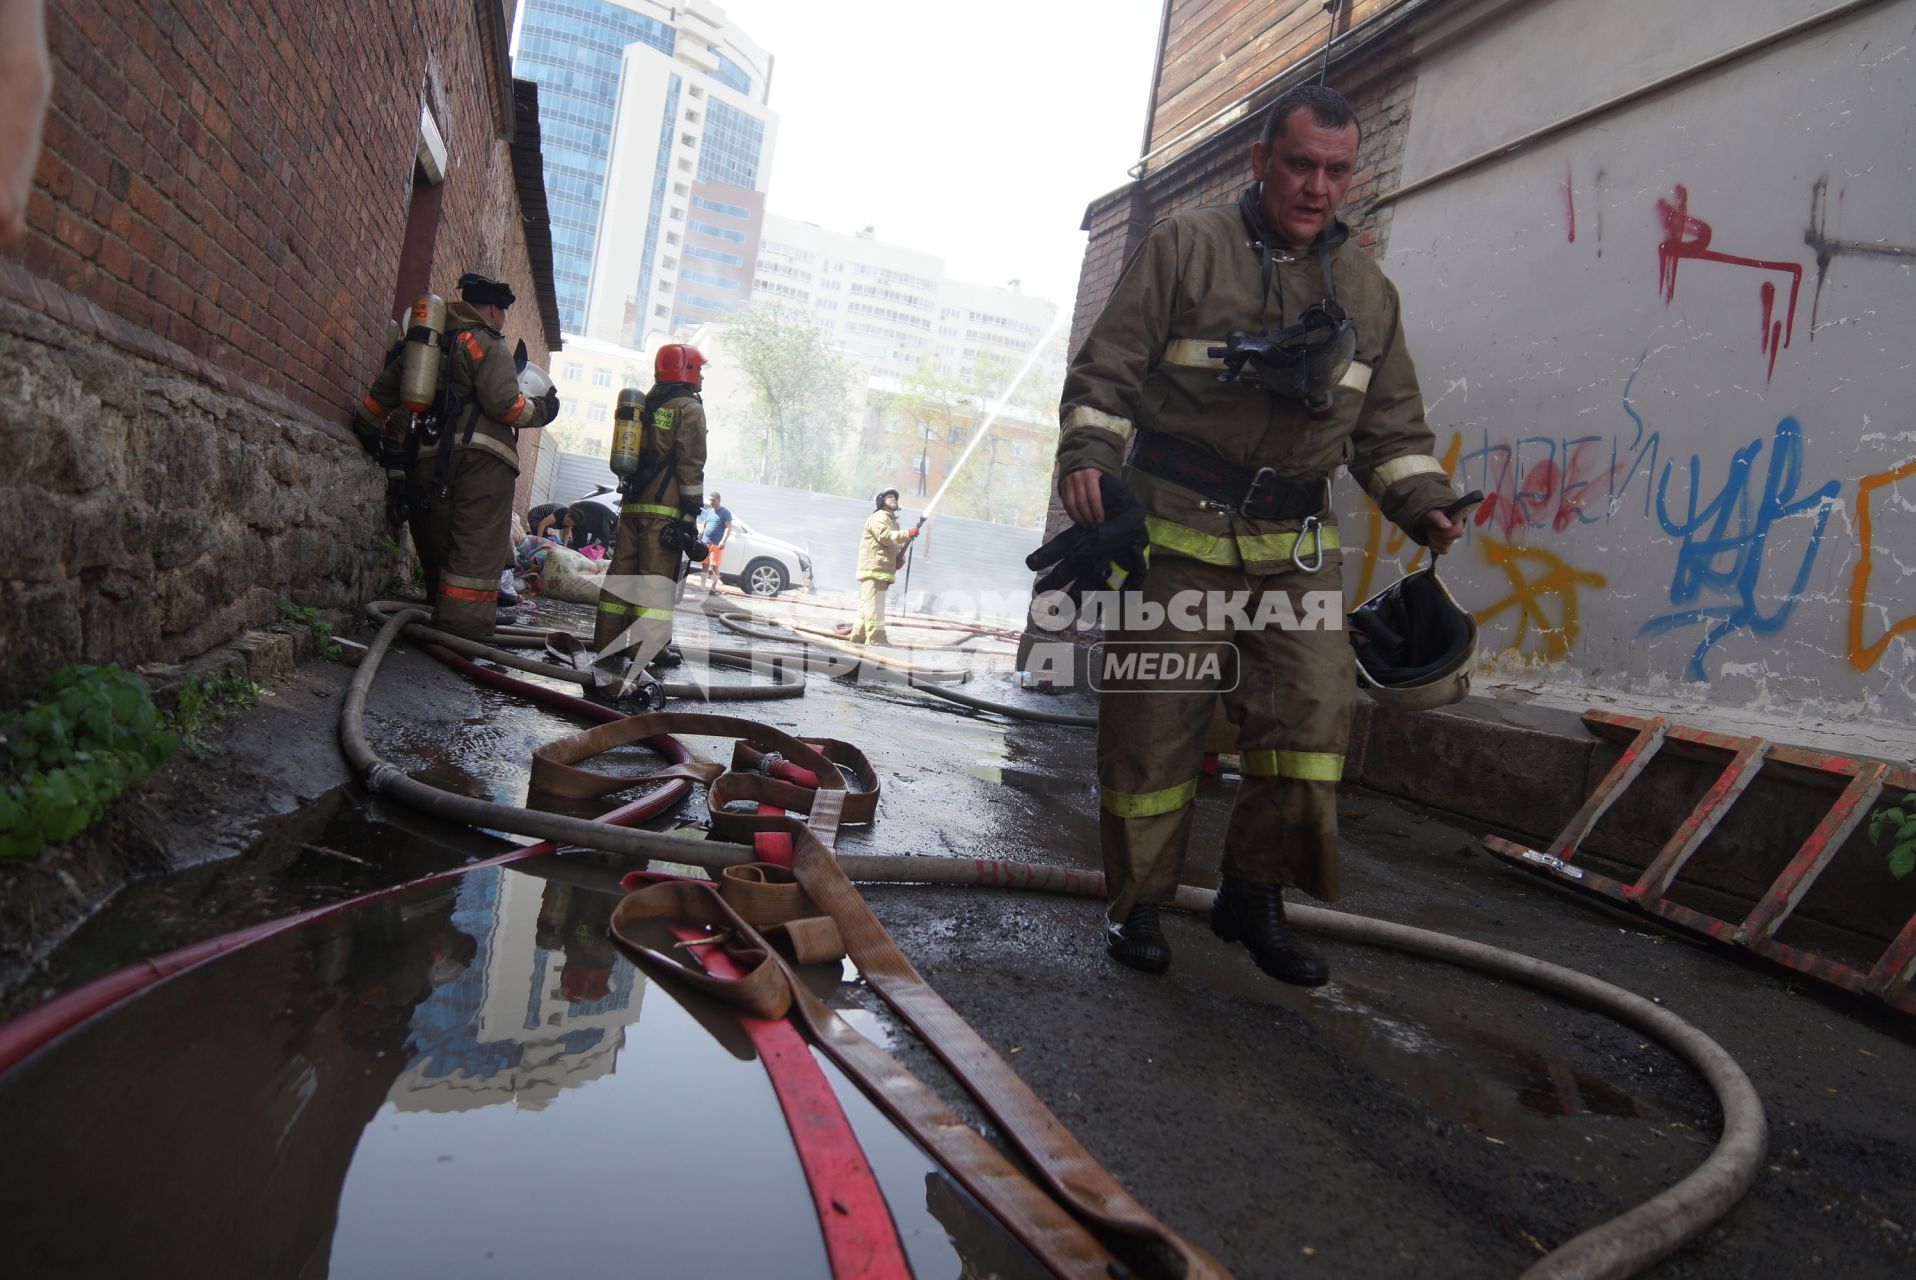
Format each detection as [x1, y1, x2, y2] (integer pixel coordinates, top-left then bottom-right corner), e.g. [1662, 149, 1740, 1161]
[353, 272, 559, 640]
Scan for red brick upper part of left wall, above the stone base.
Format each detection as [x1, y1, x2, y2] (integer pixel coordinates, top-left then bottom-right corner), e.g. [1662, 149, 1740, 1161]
[11, 0, 544, 425]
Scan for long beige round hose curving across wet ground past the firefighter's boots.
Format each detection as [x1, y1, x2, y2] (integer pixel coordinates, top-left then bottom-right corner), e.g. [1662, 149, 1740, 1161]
[339, 609, 1768, 1280]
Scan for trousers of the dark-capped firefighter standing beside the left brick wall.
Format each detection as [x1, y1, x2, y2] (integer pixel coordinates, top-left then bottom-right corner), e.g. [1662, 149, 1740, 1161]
[410, 448, 519, 640]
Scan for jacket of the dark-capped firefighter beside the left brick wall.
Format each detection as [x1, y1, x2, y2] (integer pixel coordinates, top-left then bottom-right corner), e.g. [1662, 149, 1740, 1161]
[356, 303, 544, 471]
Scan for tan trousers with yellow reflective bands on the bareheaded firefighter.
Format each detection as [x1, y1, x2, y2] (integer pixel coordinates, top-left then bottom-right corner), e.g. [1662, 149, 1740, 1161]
[1094, 550, 1357, 920]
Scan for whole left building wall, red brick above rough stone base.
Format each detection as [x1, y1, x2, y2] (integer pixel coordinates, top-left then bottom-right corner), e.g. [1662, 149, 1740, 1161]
[0, 0, 558, 705]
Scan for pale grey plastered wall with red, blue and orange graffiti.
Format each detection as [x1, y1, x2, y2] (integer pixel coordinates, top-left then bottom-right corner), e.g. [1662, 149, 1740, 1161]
[1371, 0, 1916, 722]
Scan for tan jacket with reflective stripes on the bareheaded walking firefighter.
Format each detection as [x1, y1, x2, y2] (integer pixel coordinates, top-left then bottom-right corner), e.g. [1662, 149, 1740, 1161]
[1058, 192, 1456, 575]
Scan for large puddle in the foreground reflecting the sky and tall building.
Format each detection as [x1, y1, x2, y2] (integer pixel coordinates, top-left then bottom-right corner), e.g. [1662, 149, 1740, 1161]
[0, 868, 1040, 1276]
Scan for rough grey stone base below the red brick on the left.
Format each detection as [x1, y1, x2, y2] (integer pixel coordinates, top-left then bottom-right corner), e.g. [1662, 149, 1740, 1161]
[0, 301, 391, 705]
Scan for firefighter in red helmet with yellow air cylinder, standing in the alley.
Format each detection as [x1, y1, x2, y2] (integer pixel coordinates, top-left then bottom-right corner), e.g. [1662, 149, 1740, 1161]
[592, 343, 707, 673]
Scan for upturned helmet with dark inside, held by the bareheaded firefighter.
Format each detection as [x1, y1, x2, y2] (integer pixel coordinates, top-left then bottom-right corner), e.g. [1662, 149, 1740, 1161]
[1349, 561, 1477, 711]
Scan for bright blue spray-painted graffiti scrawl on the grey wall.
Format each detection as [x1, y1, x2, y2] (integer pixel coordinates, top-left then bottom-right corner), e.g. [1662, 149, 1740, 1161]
[1638, 418, 1841, 680]
